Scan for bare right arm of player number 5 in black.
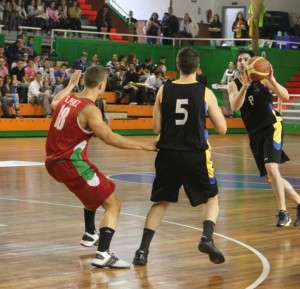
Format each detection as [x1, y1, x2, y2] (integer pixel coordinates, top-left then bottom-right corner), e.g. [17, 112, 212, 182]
[205, 88, 227, 134]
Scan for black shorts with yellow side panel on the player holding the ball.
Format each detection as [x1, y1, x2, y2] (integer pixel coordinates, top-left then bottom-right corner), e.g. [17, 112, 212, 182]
[249, 122, 290, 177]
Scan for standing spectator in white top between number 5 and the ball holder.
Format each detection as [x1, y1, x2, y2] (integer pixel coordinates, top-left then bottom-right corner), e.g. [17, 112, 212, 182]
[221, 61, 239, 117]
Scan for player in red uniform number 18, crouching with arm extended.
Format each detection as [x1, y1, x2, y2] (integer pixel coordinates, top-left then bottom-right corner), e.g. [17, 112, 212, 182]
[45, 66, 156, 268]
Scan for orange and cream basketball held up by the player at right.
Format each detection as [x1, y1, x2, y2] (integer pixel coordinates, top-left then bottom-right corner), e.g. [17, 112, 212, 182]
[246, 56, 271, 81]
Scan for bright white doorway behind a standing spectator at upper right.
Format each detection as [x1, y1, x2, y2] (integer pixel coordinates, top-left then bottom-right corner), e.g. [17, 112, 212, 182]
[222, 6, 246, 46]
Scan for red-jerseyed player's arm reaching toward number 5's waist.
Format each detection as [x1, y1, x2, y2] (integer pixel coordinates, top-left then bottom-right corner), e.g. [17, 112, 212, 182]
[80, 106, 156, 151]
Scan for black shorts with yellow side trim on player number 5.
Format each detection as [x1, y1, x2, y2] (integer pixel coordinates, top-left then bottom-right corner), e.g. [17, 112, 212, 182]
[151, 149, 218, 207]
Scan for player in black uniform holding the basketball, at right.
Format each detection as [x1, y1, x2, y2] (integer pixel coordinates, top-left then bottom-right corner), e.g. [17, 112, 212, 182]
[228, 49, 300, 227]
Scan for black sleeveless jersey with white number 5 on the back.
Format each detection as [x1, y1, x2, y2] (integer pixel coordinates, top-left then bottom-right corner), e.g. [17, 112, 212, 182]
[157, 82, 208, 151]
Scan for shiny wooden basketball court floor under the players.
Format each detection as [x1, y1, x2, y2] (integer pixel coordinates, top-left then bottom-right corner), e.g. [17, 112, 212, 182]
[0, 135, 300, 289]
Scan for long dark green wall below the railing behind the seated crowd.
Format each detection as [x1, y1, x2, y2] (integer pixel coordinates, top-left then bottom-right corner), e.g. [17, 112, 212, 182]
[54, 38, 300, 105]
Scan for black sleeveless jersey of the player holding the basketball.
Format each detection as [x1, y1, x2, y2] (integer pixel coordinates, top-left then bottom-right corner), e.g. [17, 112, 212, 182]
[234, 77, 282, 135]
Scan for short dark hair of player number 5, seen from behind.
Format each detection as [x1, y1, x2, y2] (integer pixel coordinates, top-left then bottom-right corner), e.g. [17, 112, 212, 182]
[176, 47, 200, 75]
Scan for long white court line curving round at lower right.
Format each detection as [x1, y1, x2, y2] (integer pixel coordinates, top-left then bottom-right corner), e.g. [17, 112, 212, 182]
[0, 197, 270, 289]
